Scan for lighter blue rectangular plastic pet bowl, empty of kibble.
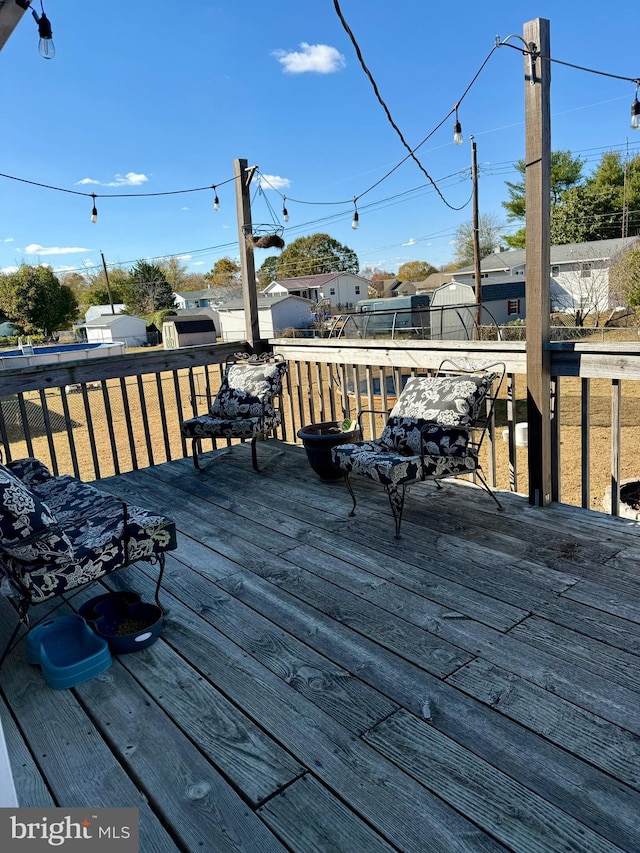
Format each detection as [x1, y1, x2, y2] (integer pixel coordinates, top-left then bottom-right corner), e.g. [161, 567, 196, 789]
[27, 614, 112, 690]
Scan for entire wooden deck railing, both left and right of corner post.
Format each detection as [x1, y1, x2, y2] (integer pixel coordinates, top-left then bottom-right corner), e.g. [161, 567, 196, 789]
[0, 338, 640, 514]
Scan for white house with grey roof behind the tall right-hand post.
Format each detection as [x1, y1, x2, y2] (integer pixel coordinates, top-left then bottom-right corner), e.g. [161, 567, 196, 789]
[453, 237, 640, 323]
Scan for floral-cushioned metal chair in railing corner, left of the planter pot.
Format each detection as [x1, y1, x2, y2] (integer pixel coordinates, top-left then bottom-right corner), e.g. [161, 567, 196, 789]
[180, 353, 287, 473]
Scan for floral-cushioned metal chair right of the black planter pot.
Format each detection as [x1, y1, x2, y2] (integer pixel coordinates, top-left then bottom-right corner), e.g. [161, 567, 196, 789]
[332, 359, 506, 538]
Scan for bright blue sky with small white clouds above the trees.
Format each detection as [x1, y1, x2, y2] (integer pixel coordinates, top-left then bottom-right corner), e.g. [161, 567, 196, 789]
[0, 0, 640, 280]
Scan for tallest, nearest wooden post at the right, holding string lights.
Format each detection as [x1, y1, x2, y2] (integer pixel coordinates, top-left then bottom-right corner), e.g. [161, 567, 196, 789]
[523, 18, 551, 506]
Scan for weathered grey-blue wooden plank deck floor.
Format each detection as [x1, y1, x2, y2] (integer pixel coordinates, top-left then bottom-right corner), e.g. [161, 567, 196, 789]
[0, 441, 640, 853]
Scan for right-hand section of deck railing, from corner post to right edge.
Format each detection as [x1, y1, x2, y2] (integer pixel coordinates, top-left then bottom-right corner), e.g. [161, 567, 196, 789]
[271, 339, 640, 515]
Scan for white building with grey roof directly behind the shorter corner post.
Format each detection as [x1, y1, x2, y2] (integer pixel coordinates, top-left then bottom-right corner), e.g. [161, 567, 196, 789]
[218, 296, 313, 341]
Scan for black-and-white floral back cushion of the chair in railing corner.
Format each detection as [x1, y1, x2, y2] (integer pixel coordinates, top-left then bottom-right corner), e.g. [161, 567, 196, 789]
[210, 362, 286, 420]
